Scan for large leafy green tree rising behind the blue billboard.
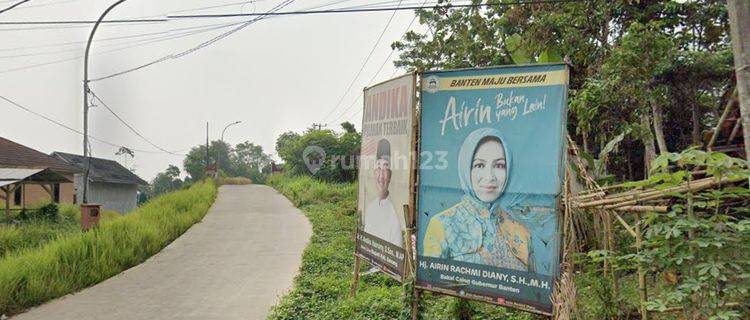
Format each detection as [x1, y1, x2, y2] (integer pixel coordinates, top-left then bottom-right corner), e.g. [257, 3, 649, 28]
[392, 0, 731, 178]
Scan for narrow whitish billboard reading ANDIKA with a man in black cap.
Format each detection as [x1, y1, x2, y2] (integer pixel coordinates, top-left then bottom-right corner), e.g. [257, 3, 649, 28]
[355, 74, 416, 281]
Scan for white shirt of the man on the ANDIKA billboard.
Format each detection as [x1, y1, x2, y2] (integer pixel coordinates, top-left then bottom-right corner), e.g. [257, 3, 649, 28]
[365, 197, 404, 248]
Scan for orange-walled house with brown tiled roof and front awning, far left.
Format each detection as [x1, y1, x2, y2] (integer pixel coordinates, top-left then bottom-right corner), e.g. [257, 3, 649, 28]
[0, 137, 83, 214]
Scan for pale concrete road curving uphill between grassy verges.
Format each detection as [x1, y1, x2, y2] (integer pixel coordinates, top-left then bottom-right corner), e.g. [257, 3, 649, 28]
[12, 185, 311, 320]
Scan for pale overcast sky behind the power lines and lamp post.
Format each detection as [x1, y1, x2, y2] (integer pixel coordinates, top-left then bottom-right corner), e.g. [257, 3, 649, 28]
[0, 0, 421, 180]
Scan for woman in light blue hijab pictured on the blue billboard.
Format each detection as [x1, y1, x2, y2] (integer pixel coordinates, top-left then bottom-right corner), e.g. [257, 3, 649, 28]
[423, 128, 535, 271]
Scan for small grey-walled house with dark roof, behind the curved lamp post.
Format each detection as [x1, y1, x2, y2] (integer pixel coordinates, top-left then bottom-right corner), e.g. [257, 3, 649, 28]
[52, 152, 148, 214]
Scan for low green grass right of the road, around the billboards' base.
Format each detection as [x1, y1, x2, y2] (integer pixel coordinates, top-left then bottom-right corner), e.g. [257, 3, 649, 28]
[266, 174, 541, 320]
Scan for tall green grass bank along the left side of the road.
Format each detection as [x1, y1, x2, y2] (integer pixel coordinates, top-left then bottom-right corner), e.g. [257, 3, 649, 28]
[0, 181, 217, 315]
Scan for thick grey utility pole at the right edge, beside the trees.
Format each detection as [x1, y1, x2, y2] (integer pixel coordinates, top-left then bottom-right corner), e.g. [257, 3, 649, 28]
[727, 0, 750, 159]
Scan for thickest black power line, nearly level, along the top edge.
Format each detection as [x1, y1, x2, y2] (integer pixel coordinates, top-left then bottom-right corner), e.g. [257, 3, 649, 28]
[167, 0, 591, 19]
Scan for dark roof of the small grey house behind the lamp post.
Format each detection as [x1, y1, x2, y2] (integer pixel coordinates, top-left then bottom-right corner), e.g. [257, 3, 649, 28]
[52, 152, 148, 186]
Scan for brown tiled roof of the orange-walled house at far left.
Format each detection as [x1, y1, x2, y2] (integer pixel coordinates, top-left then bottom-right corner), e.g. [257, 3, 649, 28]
[0, 137, 83, 173]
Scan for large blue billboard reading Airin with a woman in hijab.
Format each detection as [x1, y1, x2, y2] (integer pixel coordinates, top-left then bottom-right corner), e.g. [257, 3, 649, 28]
[417, 64, 568, 315]
